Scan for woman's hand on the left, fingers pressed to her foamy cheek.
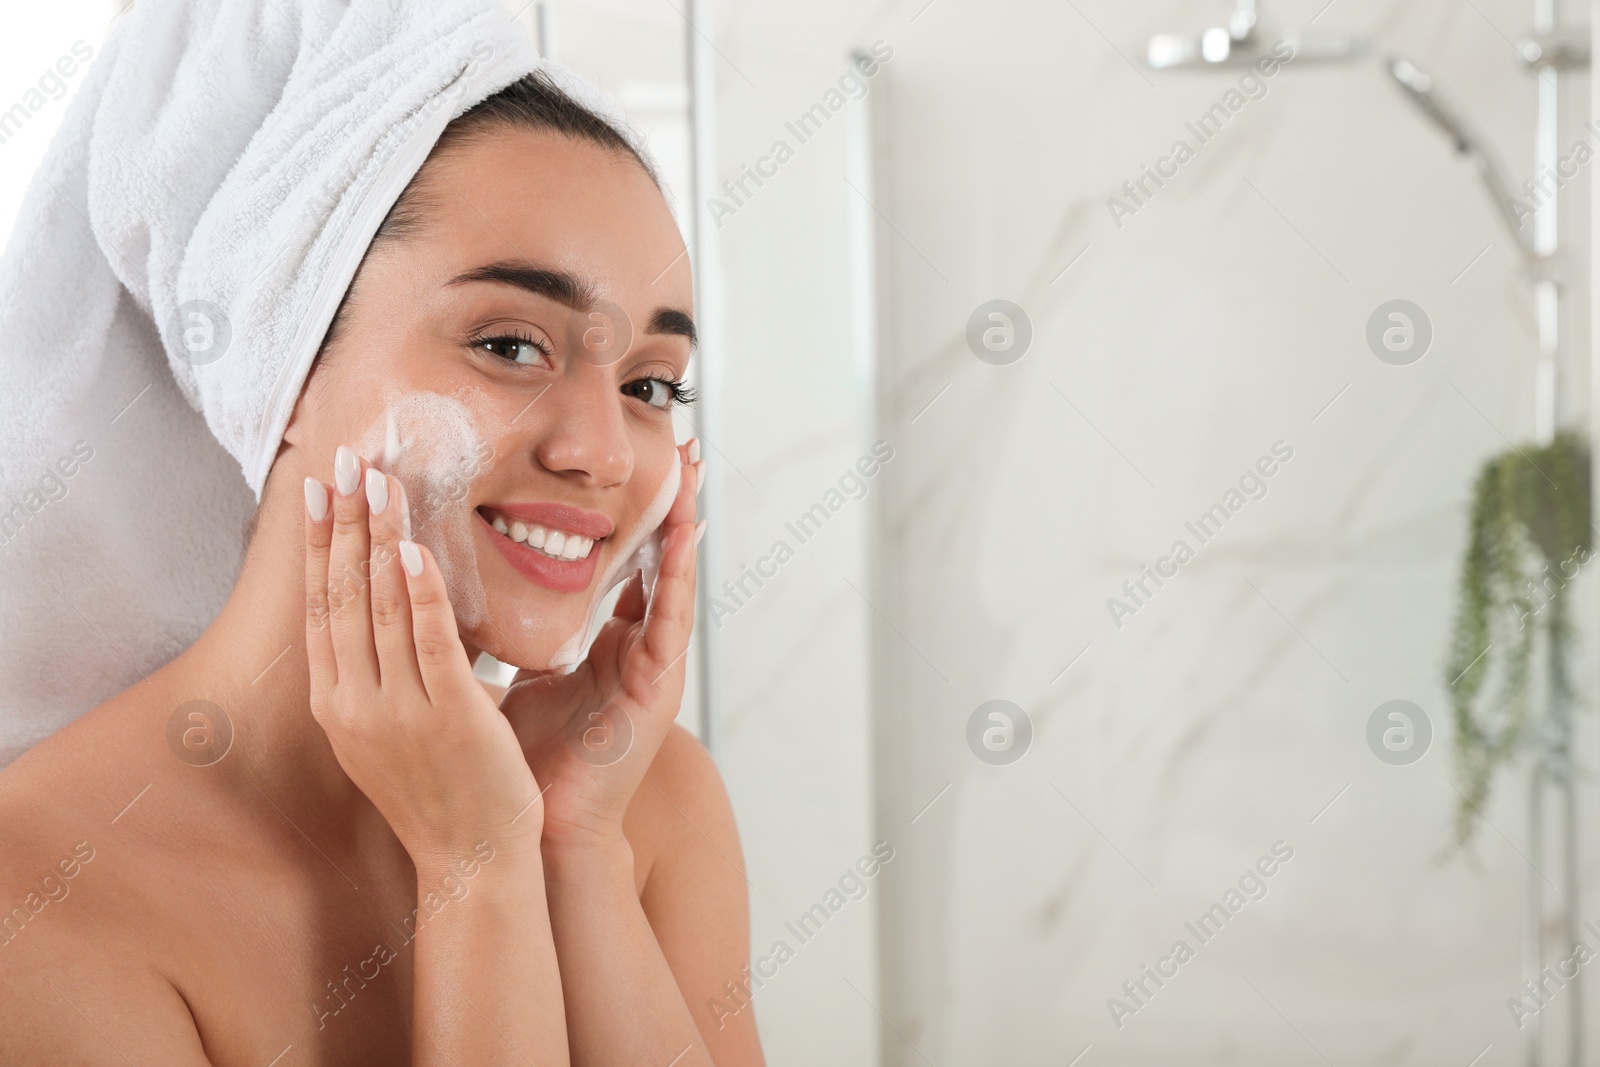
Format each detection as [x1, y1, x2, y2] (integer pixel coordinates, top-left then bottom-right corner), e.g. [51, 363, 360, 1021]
[306, 446, 544, 869]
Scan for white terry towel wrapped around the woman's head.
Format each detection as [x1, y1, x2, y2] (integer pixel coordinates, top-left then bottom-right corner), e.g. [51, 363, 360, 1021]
[0, 0, 648, 765]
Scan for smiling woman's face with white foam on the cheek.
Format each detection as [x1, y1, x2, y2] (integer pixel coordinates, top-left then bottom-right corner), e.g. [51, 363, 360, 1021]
[285, 128, 693, 667]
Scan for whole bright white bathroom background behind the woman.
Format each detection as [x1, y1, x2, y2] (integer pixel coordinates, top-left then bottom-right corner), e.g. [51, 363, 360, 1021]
[0, 0, 1600, 1067]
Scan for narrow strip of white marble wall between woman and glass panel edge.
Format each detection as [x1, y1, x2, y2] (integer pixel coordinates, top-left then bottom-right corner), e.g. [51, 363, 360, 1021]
[701, 35, 902, 1067]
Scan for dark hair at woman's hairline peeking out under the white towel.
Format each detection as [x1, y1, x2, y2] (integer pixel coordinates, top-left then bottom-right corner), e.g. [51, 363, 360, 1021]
[315, 70, 661, 363]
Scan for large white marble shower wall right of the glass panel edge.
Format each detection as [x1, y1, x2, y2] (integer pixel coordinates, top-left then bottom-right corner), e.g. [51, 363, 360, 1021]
[717, 0, 1600, 1067]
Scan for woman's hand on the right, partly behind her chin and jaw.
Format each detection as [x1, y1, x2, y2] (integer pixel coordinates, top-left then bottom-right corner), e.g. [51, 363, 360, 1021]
[501, 445, 704, 848]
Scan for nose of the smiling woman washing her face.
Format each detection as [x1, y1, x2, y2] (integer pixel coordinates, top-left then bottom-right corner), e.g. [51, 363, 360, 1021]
[523, 366, 634, 488]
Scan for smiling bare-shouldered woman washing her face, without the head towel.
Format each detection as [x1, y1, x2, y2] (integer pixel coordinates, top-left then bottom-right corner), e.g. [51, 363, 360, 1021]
[0, 75, 762, 1067]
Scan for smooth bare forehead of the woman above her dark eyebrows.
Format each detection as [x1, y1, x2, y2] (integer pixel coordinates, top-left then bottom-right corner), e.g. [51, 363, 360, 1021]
[419, 126, 691, 310]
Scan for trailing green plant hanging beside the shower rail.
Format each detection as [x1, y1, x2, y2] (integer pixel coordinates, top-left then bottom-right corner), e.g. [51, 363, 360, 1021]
[1445, 432, 1592, 848]
